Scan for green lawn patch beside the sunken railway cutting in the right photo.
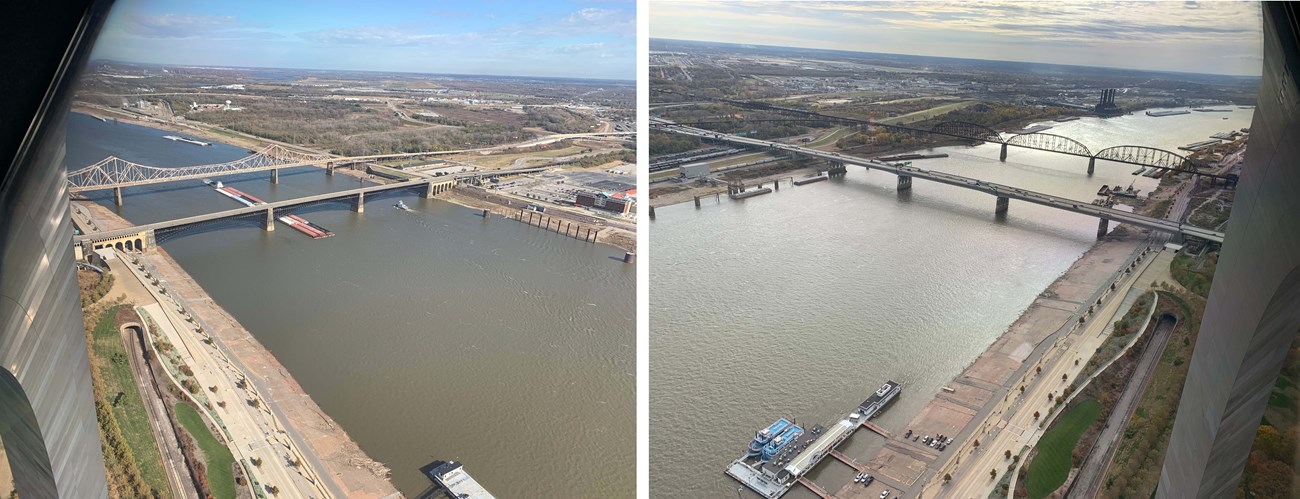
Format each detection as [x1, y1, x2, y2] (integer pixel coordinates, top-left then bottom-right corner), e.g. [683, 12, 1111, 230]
[1026, 399, 1101, 499]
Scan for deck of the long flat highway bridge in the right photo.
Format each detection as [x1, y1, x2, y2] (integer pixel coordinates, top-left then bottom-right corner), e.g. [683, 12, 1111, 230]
[651, 120, 1223, 244]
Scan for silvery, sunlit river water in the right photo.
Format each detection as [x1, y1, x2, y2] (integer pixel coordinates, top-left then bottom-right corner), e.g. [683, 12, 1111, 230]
[649, 108, 1252, 498]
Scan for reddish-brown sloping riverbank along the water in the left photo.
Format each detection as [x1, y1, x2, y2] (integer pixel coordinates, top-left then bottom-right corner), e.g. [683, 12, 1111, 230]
[74, 201, 400, 498]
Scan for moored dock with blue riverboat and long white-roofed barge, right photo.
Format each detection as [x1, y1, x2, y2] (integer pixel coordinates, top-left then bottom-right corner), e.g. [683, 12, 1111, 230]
[725, 381, 902, 499]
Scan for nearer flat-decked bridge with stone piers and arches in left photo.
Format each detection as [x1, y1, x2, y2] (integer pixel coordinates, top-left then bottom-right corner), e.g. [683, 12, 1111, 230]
[73, 168, 546, 252]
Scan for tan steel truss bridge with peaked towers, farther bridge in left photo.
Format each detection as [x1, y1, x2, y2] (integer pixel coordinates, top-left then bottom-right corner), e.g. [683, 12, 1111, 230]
[68, 131, 636, 205]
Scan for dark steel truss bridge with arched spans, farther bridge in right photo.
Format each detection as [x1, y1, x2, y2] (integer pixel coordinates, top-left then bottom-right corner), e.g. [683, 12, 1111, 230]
[660, 96, 1230, 181]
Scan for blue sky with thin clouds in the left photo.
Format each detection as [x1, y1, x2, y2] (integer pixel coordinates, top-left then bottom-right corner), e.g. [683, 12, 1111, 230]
[92, 0, 636, 79]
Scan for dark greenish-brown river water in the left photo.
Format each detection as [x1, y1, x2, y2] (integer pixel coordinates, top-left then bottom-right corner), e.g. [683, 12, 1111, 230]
[66, 114, 636, 498]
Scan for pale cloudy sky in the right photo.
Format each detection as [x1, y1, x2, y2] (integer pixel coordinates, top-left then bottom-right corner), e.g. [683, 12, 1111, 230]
[650, 0, 1264, 77]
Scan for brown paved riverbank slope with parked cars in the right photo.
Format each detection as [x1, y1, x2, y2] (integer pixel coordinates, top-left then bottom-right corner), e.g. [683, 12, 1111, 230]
[837, 227, 1147, 498]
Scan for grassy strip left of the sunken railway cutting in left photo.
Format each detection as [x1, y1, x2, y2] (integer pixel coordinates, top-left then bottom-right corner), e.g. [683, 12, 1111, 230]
[91, 301, 172, 498]
